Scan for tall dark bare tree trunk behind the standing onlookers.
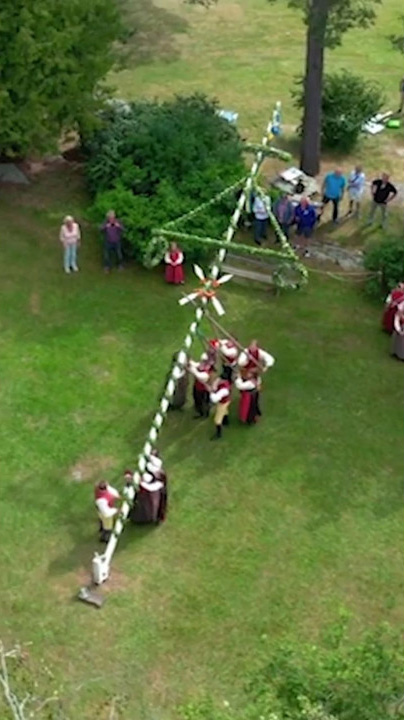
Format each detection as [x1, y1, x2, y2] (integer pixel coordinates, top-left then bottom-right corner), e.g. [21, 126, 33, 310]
[300, 0, 328, 175]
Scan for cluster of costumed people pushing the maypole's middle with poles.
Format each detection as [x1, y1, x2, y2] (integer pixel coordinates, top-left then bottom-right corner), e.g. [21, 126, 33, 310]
[187, 338, 275, 440]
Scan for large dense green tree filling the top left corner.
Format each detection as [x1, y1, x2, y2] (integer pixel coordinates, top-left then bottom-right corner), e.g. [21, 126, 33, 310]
[0, 0, 120, 156]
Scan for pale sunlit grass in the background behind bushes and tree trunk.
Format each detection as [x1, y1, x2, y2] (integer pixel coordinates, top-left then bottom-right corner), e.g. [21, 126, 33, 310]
[111, 0, 403, 181]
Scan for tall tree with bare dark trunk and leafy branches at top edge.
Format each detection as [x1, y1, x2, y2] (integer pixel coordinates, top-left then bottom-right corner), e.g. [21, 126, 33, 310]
[282, 0, 381, 175]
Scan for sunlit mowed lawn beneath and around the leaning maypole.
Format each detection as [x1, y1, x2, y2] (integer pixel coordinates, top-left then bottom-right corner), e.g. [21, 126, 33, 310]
[0, 166, 403, 720]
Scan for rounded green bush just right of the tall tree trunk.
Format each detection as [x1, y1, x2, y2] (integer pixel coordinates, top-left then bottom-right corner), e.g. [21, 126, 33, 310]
[292, 70, 384, 152]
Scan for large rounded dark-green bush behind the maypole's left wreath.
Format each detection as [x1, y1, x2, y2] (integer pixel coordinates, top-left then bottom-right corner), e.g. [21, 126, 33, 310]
[83, 95, 245, 260]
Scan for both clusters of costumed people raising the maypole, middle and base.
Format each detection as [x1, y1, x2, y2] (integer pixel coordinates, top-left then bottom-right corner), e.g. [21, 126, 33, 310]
[94, 338, 275, 543]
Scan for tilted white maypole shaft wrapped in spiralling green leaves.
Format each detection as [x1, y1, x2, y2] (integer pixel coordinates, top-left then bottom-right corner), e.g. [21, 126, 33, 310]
[92, 111, 278, 585]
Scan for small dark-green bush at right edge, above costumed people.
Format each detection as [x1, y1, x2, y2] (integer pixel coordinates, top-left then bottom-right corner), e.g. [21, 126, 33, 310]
[364, 238, 404, 297]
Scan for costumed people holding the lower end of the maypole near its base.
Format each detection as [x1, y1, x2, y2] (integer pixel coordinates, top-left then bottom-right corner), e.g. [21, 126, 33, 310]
[94, 450, 167, 543]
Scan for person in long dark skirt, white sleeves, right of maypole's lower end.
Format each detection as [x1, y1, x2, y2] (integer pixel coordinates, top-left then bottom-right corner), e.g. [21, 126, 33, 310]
[131, 455, 167, 525]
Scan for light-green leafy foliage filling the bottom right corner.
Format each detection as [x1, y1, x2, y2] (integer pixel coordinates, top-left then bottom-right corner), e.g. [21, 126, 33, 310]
[182, 617, 404, 720]
